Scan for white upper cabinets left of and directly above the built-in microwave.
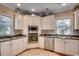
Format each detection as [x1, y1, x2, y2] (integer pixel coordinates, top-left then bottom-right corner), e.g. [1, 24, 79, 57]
[15, 14, 40, 30]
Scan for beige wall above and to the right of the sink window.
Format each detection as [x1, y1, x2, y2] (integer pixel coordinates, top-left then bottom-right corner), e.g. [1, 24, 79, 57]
[55, 10, 79, 35]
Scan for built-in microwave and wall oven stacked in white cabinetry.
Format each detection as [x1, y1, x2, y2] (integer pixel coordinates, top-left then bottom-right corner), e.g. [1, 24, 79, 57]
[28, 26, 38, 43]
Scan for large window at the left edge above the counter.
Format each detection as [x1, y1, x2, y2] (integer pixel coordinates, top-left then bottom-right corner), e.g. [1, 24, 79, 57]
[0, 15, 11, 36]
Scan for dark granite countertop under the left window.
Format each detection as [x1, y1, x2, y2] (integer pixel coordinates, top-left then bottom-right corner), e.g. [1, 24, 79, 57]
[0, 35, 27, 43]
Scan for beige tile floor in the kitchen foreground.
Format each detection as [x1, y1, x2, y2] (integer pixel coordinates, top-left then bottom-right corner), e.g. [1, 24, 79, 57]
[18, 49, 60, 56]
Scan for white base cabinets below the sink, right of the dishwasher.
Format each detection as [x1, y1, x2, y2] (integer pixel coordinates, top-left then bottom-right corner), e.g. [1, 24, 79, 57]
[55, 38, 79, 55]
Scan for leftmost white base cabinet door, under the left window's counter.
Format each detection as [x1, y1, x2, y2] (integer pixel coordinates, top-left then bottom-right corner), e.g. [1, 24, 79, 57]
[1, 41, 11, 56]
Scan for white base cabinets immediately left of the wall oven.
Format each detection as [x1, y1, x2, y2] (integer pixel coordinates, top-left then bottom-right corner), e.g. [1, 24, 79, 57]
[12, 38, 27, 55]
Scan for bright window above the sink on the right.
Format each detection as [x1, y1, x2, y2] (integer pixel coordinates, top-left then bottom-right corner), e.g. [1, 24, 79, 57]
[56, 19, 72, 35]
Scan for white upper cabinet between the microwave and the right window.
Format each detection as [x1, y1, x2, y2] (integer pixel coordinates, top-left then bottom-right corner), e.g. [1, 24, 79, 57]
[41, 15, 55, 30]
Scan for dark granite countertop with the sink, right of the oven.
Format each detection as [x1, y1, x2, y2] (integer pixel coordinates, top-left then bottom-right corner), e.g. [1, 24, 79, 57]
[39, 34, 79, 40]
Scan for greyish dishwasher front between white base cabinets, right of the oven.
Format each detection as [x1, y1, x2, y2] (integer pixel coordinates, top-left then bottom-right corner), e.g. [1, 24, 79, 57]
[44, 37, 54, 51]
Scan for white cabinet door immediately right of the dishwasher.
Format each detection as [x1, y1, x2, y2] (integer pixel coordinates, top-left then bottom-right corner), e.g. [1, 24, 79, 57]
[55, 38, 64, 53]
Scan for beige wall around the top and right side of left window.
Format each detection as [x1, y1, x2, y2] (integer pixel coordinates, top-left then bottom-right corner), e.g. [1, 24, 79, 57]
[0, 4, 15, 34]
